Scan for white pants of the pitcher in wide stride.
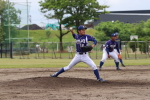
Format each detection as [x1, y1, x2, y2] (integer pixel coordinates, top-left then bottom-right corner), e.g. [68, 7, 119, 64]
[64, 52, 97, 71]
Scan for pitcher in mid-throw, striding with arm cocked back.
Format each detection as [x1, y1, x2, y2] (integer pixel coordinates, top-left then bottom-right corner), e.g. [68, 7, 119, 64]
[50, 25, 105, 82]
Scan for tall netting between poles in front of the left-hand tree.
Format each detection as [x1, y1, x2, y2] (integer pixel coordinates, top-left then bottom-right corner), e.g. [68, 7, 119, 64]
[4, 0, 31, 43]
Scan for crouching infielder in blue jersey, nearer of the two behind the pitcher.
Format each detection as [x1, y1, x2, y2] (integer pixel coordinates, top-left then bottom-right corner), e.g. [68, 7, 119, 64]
[99, 34, 121, 70]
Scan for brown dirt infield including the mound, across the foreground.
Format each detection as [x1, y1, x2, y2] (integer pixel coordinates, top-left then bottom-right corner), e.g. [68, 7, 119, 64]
[0, 66, 150, 100]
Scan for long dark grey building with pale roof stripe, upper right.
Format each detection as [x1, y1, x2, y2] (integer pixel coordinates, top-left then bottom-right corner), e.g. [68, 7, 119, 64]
[93, 10, 150, 26]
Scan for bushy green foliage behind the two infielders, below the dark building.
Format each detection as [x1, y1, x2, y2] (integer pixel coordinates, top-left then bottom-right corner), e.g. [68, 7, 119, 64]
[94, 21, 133, 41]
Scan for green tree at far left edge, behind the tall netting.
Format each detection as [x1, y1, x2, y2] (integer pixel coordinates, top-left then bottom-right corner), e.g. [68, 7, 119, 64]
[0, 0, 21, 42]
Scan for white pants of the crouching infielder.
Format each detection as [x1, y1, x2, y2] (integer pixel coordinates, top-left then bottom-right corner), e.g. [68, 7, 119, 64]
[101, 49, 119, 62]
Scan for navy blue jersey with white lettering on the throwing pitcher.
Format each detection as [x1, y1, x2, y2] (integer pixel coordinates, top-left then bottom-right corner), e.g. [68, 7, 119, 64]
[72, 34, 97, 52]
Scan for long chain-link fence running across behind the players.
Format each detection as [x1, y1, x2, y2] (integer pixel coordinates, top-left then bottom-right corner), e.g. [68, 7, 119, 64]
[9, 41, 150, 59]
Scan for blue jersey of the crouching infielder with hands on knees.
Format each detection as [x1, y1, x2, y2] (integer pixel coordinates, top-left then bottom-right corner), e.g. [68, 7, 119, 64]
[105, 40, 120, 55]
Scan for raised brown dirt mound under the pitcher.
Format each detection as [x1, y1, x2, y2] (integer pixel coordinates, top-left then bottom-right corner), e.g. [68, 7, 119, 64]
[6, 77, 108, 89]
